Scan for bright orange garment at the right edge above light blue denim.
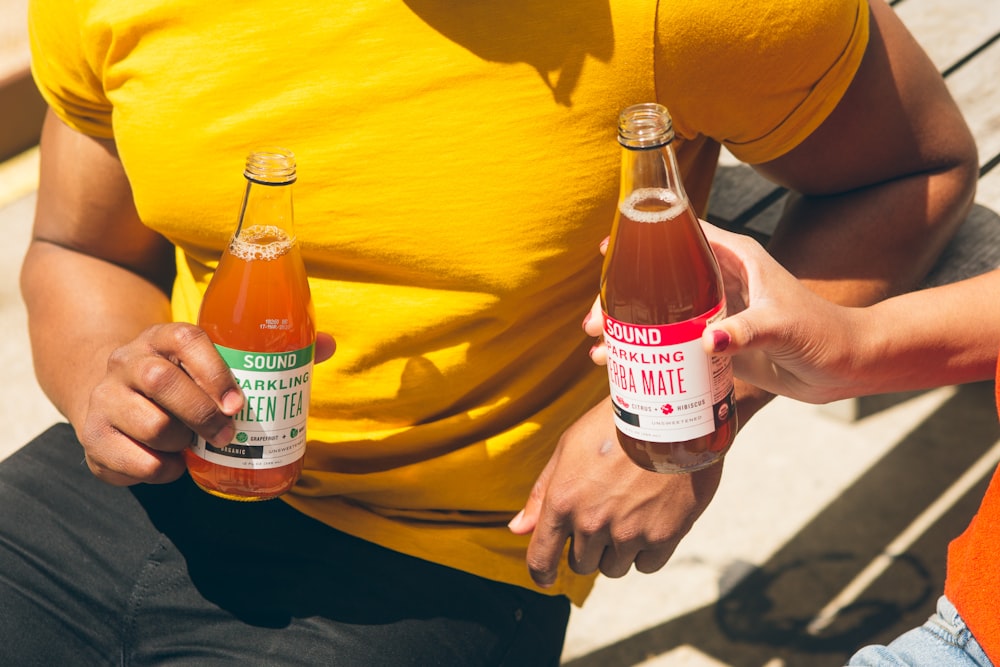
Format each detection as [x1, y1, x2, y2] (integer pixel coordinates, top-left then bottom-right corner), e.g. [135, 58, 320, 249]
[944, 365, 1000, 664]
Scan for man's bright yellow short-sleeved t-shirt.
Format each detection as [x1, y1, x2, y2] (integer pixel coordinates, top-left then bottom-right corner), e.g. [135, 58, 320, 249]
[30, 0, 868, 603]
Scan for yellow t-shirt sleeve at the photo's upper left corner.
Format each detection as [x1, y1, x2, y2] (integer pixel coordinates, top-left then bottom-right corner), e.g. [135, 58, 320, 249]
[28, 0, 112, 139]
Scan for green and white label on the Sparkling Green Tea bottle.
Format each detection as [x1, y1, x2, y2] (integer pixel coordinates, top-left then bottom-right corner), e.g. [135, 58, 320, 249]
[191, 346, 313, 470]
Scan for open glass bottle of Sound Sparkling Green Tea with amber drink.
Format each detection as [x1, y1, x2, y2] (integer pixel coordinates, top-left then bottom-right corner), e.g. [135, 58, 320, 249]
[185, 149, 316, 500]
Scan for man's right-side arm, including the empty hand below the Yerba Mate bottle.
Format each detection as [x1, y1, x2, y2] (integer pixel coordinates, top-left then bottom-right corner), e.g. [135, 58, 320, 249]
[511, 0, 977, 584]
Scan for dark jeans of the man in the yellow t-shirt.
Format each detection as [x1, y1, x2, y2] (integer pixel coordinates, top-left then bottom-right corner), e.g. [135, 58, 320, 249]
[0, 425, 569, 667]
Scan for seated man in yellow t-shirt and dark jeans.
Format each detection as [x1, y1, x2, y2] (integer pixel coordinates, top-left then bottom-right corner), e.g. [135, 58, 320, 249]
[0, 0, 977, 665]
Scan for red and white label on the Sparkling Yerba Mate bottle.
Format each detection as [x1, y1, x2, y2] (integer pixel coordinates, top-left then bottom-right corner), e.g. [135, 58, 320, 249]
[604, 303, 733, 442]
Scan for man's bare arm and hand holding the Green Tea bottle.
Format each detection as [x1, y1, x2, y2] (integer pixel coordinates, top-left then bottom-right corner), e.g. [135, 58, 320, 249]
[21, 112, 242, 484]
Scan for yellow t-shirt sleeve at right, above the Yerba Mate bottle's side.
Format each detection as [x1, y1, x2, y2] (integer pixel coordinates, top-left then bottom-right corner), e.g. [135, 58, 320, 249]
[656, 0, 869, 163]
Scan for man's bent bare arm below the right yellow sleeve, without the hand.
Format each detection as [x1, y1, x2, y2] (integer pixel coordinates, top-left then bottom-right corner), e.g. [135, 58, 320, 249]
[740, 0, 978, 423]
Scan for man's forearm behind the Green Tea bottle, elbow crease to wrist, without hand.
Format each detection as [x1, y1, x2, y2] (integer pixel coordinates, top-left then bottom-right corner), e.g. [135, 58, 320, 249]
[21, 240, 170, 426]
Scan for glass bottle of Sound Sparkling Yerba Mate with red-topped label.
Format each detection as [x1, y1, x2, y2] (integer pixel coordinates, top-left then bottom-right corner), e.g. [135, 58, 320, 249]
[601, 104, 736, 473]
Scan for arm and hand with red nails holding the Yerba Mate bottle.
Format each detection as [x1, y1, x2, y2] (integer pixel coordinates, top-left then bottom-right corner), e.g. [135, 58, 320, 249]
[703, 224, 1000, 403]
